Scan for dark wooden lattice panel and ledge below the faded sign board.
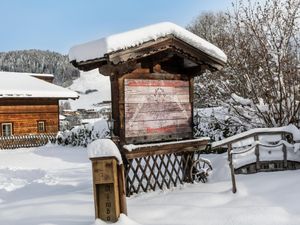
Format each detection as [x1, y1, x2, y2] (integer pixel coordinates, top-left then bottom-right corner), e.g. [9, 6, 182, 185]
[124, 139, 208, 196]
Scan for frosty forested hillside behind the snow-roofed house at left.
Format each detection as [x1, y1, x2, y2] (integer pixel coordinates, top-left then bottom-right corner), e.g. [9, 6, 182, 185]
[0, 49, 80, 86]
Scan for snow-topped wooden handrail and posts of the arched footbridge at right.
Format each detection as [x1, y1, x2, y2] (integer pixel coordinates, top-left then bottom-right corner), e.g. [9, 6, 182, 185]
[211, 128, 294, 193]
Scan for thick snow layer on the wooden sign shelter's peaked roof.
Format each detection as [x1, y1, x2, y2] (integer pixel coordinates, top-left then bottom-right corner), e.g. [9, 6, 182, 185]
[69, 22, 227, 63]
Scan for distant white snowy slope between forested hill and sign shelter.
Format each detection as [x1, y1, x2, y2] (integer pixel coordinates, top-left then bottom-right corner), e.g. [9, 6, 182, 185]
[69, 69, 110, 110]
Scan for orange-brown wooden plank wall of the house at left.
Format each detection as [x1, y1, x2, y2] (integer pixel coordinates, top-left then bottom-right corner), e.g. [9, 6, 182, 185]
[0, 99, 59, 136]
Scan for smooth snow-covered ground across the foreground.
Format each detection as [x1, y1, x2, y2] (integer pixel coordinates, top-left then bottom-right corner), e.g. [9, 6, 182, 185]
[0, 145, 300, 225]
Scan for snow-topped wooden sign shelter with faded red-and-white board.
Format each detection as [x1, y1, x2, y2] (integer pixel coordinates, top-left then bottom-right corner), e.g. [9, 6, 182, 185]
[69, 23, 227, 195]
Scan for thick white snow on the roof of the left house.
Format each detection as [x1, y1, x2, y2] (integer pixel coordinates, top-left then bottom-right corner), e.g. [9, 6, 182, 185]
[0, 71, 78, 99]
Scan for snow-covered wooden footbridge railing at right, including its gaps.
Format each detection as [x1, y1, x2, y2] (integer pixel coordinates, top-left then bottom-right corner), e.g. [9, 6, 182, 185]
[212, 128, 300, 193]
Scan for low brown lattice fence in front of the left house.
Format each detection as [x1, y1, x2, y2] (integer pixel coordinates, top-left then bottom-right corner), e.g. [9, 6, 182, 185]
[0, 133, 56, 149]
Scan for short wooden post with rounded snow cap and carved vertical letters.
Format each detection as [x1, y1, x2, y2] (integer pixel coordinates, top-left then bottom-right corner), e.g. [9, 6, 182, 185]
[88, 139, 127, 222]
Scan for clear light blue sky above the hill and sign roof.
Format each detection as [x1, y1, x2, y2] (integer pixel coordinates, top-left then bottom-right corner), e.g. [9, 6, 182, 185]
[0, 0, 232, 54]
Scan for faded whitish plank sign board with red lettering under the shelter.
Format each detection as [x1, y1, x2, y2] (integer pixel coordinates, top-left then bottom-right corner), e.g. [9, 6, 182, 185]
[124, 79, 192, 142]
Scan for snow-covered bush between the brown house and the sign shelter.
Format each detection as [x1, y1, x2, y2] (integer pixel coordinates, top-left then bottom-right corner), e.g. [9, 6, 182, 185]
[57, 119, 109, 147]
